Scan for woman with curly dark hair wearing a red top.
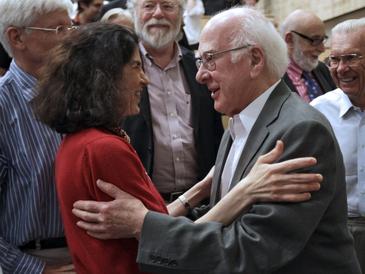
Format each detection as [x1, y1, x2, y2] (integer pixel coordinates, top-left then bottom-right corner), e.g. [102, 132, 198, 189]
[32, 24, 319, 274]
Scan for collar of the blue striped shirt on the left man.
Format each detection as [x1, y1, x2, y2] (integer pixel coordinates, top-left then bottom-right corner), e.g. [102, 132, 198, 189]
[9, 60, 37, 102]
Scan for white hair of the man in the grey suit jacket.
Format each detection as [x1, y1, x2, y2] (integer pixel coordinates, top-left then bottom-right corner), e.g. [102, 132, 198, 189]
[208, 7, 289, 78]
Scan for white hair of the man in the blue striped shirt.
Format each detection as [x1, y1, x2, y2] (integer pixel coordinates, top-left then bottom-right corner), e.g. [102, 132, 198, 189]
[0, 0, 73, 56]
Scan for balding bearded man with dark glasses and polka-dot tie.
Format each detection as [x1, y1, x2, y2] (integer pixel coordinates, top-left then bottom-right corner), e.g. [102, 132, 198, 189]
[273, 10, 336, 102]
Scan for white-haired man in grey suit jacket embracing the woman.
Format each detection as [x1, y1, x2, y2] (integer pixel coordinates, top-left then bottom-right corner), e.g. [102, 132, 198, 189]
[74, 8, 361, 274]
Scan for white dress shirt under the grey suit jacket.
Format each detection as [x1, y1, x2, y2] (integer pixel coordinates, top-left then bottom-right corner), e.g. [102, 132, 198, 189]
[221, 81, 280, 197]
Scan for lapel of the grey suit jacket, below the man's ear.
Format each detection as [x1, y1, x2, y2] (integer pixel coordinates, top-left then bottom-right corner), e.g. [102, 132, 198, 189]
[230, 81, 290, 189]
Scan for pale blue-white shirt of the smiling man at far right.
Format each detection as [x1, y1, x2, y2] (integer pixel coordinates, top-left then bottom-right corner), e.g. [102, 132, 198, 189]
[311, 89, 365, 217]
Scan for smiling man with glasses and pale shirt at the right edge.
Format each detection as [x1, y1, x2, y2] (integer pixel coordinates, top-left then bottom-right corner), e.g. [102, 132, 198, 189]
[311, 18, 365, 273]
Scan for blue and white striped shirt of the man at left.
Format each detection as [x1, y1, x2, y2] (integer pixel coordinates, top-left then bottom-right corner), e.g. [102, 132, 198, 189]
[0, 61, 64, 273]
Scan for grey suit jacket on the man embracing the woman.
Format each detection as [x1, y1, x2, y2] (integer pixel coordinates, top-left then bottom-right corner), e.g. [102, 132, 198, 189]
[137, 81, 361, 274]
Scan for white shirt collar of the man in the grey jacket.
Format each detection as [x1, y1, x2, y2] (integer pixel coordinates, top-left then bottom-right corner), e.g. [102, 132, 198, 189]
[229, 80, 280, 140]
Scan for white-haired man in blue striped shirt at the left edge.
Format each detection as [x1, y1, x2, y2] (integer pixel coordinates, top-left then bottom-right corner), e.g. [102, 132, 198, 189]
[0, 0, 74, 273]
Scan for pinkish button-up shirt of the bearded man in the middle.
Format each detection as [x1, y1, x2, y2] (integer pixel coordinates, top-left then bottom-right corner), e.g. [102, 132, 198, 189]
[140, 43, 198, 193]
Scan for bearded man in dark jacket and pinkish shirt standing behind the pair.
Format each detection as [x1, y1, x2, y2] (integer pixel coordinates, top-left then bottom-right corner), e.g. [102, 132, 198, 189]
[123, 0, 223, 203]
